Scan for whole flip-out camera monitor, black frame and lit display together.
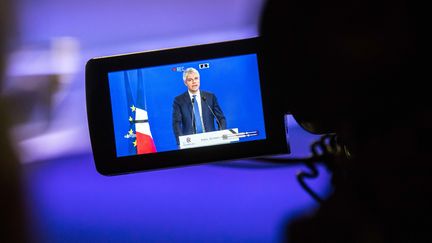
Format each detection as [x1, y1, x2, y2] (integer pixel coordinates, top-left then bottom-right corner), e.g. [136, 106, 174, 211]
[86, 37, 290, 175]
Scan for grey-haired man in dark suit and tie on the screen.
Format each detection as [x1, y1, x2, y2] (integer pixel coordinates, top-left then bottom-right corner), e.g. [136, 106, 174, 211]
[172, 68, 226, 144]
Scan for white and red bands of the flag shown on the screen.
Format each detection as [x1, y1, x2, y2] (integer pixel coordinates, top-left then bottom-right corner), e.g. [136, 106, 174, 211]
[135, 107, 156, 154]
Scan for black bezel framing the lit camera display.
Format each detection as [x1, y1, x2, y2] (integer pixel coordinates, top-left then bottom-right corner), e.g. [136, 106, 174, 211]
[86, 37, 289, 175]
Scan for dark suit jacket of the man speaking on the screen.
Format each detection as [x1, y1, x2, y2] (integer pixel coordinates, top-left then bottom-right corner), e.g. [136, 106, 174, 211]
[172, 90, 226, 144]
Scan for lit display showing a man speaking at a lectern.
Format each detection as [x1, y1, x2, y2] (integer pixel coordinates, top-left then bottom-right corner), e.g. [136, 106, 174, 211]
[107, 54, 266, 157]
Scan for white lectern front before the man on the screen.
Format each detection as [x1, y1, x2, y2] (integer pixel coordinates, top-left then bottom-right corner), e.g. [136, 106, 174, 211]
[179, 128, 240, 149]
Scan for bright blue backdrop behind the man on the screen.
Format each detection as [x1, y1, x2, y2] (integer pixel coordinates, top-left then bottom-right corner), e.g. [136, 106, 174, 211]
[108, 54, 266, 156]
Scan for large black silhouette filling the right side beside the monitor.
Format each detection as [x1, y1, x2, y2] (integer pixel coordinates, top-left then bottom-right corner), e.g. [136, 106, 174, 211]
[260, 0, 432, 242]
